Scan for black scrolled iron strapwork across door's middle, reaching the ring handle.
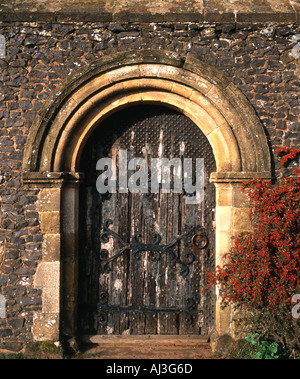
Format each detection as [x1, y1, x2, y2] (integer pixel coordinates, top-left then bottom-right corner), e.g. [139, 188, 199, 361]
[100, 220, 208, 277]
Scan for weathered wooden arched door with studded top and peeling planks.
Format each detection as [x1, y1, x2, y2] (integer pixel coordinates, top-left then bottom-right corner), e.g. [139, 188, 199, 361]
[79, 105, 215, 335]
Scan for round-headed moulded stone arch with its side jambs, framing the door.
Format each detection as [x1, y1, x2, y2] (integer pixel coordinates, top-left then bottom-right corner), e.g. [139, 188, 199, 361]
[23, 50, 271, 348]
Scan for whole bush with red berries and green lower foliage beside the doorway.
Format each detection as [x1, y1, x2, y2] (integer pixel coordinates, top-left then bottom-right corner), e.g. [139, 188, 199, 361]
[206, 148, 300, 357]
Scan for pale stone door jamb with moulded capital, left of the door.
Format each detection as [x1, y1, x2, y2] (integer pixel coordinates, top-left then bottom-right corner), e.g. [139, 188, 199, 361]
[23, 173, 84, 342]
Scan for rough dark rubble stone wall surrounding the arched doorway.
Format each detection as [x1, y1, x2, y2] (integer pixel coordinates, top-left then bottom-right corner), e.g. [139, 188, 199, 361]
[0, 0, 300, 352]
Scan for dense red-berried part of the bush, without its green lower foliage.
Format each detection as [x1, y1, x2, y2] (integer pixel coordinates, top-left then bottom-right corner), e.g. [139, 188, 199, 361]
[206, 148, 300, 312]
